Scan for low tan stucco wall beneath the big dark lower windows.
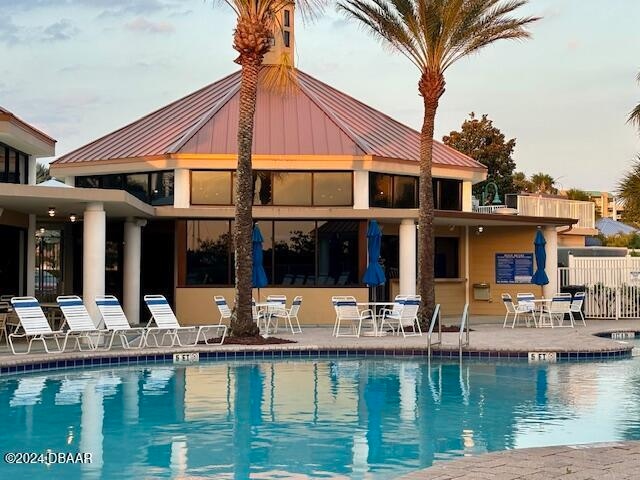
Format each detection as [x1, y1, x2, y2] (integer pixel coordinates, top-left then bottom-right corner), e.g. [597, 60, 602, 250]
[176, 287, 369, 325]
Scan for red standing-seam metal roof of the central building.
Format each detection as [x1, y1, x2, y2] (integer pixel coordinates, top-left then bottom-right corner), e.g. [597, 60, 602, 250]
[55, 67, 485, 169]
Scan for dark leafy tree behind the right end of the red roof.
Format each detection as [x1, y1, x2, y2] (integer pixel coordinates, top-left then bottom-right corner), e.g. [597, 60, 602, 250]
[442, 112, 516, 198]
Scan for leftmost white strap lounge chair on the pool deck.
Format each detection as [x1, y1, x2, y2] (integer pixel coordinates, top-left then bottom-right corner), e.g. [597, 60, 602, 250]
[7, 297, 69, 355]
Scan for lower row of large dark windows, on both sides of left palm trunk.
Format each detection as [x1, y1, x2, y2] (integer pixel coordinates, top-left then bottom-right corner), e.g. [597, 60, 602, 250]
[186, 220, 359, 286]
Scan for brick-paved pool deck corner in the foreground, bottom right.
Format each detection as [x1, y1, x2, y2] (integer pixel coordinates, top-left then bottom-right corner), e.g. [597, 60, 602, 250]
[400, 442, 640, 480]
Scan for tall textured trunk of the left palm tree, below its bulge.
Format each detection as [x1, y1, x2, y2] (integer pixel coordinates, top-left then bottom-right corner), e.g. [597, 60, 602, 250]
[231, 61, 260, 337]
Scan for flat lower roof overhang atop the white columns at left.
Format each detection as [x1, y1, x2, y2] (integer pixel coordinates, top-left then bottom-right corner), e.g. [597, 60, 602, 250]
[0, 184, 154, 218]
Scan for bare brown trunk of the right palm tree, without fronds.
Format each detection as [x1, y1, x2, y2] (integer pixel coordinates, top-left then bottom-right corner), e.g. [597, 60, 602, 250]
[418, 72, 444, 329]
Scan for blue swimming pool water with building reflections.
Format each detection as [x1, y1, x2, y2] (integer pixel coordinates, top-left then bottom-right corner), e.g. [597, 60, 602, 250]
[0, 359, 640, 480]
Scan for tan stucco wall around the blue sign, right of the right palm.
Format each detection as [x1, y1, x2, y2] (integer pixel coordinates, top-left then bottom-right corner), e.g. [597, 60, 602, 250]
[462, 227, 542, 315]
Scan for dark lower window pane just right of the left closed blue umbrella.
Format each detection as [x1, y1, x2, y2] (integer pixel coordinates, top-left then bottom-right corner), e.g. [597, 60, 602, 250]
[273, 222, 316, 285]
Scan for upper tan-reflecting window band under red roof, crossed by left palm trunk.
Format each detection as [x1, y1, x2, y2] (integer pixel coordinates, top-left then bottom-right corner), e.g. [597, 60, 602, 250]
[191, 170, 353, 206]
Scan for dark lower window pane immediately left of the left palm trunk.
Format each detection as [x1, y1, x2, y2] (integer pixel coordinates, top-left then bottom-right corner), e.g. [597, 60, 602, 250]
[187, 220, 231, 285]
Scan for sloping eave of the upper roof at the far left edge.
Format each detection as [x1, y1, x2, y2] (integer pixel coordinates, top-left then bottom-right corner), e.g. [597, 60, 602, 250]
[0, 111, 56, 157]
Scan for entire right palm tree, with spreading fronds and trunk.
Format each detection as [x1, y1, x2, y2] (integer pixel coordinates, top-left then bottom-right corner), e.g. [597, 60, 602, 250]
[338, 0, 538, 324]
